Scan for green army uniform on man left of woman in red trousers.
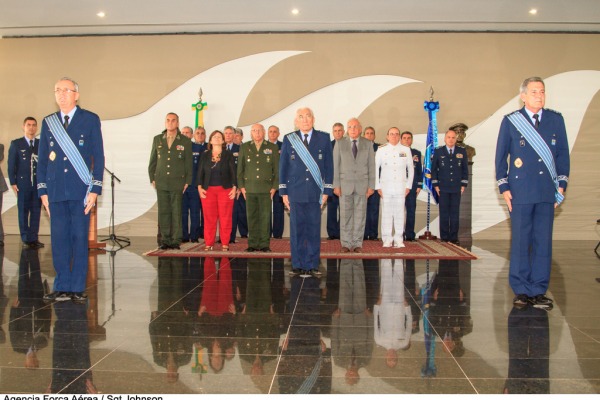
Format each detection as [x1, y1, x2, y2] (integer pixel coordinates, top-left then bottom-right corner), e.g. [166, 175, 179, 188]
[148, 129, 193, 247]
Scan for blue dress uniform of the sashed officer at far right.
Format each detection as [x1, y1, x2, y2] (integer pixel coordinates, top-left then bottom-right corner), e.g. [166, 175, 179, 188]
[496, 107, 570, 297]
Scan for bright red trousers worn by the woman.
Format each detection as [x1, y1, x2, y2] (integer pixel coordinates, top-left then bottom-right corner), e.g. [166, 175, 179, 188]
[200, 186, 233, 246]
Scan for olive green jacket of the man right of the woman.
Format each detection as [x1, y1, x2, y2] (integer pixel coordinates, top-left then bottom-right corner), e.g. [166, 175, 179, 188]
[237, 140, 279, 193]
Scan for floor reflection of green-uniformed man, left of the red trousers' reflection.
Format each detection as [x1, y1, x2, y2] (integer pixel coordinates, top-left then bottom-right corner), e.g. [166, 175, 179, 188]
[149, 257, 193, 383]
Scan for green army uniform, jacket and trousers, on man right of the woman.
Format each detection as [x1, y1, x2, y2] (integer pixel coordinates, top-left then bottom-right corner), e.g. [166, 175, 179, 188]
[237, 140, 279, 249]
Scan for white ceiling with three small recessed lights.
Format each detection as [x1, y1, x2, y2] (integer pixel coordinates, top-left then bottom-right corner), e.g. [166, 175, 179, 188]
[0, 0, 600, 37]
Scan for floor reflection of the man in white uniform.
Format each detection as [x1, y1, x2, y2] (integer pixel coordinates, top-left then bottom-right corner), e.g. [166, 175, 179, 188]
[373, 259, 412, 368]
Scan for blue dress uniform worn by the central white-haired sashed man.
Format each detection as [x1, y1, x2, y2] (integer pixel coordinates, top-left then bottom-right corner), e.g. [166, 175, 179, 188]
[279, 129, 333, 271]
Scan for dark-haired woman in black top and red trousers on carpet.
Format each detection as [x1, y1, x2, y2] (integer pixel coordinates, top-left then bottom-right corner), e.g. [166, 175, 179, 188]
[198, 131, 237, 251]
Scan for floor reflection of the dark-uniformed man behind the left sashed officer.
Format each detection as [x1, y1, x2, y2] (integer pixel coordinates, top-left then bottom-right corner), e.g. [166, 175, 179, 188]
[8, 249, 52, 369]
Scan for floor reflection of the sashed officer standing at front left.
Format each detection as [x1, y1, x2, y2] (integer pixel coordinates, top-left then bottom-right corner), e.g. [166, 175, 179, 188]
[48, 301, 98, 394]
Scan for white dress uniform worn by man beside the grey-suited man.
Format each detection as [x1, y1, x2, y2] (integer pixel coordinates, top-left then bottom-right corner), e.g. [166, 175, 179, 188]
[375, 143, 414, 247]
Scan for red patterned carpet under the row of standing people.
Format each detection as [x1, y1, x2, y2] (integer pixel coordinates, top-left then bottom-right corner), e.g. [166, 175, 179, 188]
[144, 239, 477, 260]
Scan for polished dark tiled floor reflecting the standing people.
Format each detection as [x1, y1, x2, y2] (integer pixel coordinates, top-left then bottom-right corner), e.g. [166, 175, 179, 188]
[0, 236, 600, 394]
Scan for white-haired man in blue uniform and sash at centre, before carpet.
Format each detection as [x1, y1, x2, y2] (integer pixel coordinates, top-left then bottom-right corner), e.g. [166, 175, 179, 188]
[279, 108, 333, 276]
